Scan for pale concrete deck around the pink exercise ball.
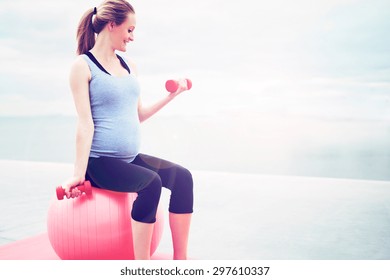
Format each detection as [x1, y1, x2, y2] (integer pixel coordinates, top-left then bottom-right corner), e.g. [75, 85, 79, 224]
[0, 161, 390, 260]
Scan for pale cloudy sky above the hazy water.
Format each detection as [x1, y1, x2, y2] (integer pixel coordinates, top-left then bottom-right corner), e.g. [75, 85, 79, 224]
[0, 0, 390, 120]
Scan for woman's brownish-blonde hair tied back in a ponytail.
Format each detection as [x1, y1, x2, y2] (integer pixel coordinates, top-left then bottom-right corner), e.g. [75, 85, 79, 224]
[77, 0, 135, 54]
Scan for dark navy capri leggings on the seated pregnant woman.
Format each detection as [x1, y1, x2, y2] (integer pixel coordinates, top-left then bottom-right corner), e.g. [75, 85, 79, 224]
[85, 154, 193, 223]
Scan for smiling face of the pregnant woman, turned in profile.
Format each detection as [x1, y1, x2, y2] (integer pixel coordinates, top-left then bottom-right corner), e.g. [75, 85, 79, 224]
[111, 13, 136, 52]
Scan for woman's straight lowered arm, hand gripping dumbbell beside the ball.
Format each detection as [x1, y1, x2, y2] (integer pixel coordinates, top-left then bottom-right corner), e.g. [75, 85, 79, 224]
[63, 57, 94, 195]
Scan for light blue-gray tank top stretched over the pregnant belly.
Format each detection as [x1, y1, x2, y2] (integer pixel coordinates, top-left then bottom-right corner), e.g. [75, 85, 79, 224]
[83, 53, 140, 162]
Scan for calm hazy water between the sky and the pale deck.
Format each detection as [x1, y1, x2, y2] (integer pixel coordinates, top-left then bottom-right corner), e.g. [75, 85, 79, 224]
[0, 114, 390, 180]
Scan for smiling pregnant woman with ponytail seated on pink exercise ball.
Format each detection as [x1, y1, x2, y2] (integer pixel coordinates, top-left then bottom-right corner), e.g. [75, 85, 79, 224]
[63, 0, 193, 259]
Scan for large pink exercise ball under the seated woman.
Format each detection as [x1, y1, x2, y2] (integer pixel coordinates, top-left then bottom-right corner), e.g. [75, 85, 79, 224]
[47, 188, 164, 260]
